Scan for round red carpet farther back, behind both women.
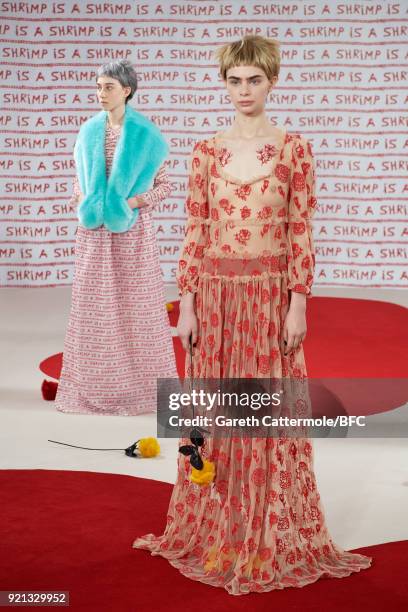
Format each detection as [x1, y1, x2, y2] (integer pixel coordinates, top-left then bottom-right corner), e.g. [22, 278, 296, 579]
[40, 297, 408, 416]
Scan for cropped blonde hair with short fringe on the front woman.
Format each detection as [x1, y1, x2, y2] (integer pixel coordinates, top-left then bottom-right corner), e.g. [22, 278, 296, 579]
[215, 34, 280, 81]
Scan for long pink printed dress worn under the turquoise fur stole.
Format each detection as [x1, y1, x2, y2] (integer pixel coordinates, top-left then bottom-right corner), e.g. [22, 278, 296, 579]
[55, 126, 177, 416]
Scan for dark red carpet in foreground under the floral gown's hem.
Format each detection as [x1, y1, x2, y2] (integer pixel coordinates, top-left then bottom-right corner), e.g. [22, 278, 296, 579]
[0, 468, 408, 612]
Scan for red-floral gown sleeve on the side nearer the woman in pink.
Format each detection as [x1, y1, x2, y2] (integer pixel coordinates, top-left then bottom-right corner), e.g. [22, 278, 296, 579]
[176, 141, 209, 296]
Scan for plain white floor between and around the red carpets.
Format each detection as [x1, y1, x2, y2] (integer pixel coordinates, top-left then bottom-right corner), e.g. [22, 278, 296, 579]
[0, 288, 408, 549]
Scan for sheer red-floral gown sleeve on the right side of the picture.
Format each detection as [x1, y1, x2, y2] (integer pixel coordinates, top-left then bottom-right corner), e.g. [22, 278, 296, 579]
[288, 136, 317, 296]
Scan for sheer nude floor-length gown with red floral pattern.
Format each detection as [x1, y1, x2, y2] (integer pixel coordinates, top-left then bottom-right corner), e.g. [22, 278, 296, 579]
[133, 132, 371, 595]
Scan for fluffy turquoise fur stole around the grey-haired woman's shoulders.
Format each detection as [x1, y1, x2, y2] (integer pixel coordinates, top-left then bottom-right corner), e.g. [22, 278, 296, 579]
[74, 105, 168, 233]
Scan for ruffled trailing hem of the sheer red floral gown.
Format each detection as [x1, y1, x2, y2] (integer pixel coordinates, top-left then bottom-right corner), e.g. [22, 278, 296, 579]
[132, 533, 372, 595]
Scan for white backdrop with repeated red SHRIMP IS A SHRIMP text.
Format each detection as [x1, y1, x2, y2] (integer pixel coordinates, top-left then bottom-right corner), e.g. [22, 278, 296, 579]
[0, 0, 408, 288]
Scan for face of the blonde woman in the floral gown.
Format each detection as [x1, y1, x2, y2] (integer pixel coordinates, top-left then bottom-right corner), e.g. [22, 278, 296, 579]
[225, 66, 278, 116]
